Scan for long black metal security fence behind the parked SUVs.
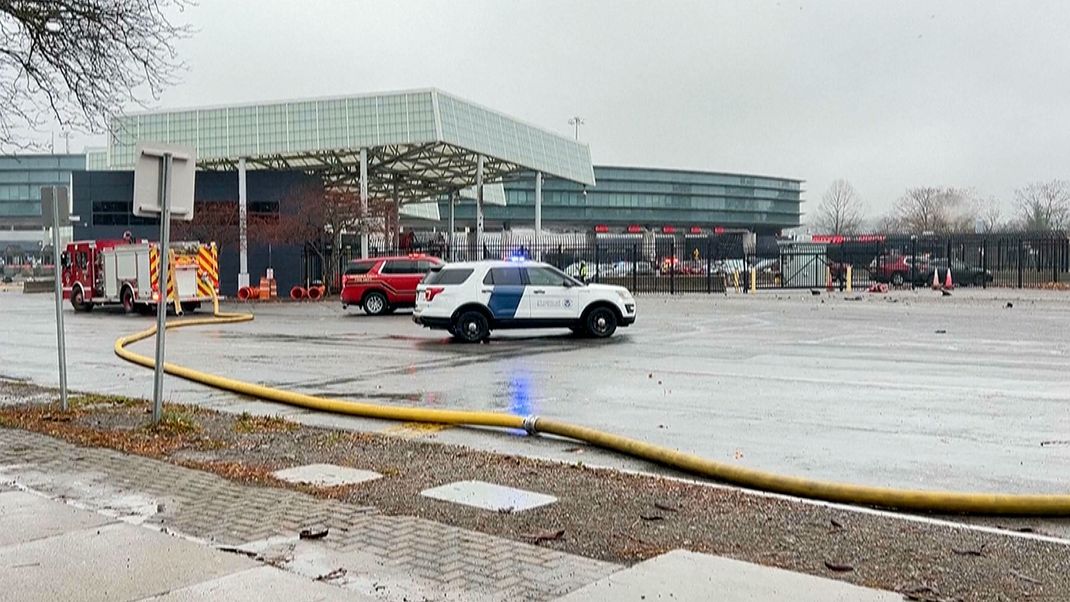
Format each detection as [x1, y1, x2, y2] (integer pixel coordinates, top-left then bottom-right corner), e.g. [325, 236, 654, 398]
[305, 233, 1070, 294]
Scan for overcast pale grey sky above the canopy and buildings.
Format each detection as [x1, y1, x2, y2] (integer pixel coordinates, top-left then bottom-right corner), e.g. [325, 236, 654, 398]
[69, 0, 1070, 226]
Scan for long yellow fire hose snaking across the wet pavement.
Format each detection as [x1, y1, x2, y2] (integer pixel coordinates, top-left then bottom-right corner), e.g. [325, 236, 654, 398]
[114, 300, 1070, 516]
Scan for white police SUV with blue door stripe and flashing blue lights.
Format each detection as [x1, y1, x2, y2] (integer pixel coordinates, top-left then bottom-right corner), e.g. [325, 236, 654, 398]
[412, 261, 636, 342]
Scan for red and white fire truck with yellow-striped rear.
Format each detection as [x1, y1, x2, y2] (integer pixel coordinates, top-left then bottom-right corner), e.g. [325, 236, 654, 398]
[60, 237, 219, 313]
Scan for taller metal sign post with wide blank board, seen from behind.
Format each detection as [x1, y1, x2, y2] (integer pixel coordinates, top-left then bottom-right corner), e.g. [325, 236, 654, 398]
[134, 142, 197, 425]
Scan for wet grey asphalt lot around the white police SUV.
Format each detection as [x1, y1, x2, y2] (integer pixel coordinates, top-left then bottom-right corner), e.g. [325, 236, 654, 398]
[0, 290, 1070, 500]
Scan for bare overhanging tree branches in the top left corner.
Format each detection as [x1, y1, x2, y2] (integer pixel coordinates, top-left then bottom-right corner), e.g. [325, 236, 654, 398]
[0, 0, 190, 149]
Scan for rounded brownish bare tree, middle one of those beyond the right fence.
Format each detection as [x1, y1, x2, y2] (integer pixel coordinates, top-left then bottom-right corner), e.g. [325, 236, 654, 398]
[891, 186, 977, 234]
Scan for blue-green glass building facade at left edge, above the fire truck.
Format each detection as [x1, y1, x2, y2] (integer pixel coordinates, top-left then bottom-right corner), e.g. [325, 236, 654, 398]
[0, 155, 86, 229]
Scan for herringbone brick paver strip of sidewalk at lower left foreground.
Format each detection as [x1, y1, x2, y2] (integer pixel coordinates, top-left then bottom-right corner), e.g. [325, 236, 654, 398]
[0, 429, 622, 600]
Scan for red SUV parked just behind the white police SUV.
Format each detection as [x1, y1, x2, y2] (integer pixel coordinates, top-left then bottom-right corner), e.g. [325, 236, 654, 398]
[341, 254, 444, 315]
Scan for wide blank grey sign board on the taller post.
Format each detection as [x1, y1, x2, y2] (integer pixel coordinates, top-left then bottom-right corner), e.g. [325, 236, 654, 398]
[134, 142, 197, 221]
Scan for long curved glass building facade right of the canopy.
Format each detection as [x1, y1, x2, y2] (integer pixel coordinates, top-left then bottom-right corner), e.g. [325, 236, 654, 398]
[439, 166, 803, 234]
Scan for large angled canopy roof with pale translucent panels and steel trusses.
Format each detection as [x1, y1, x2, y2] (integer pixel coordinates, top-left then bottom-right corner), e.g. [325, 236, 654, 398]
[99, 89, 595, 203]
